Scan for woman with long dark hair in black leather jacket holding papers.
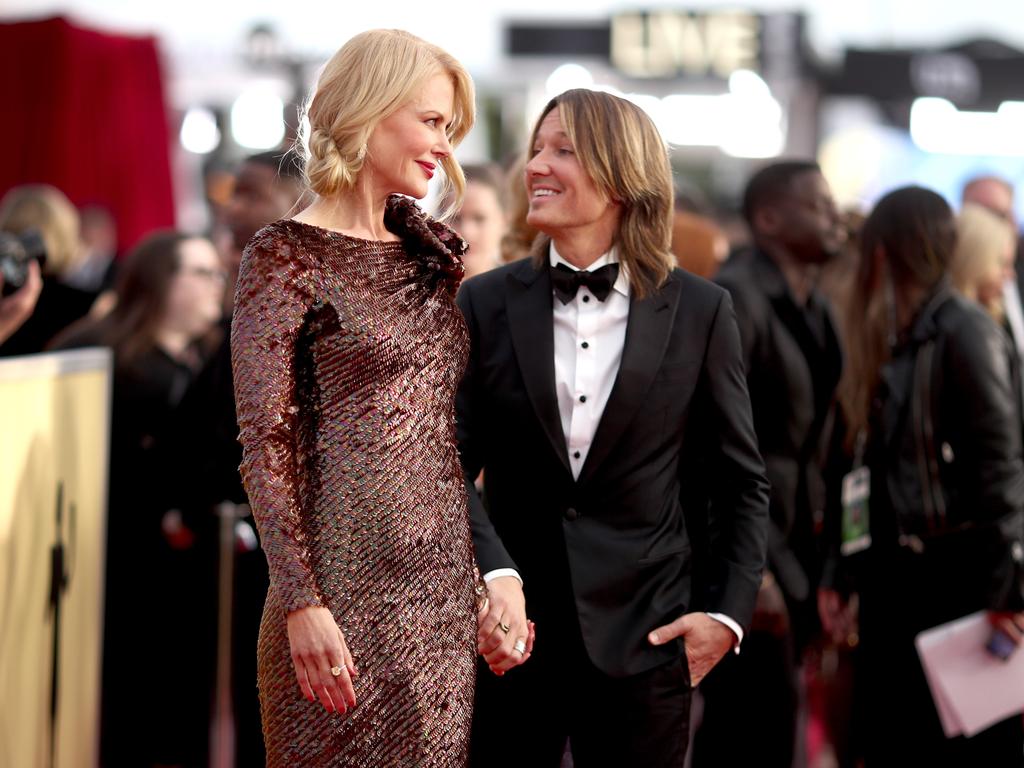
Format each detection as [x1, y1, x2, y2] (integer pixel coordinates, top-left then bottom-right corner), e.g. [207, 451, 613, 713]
[822, 187, 1024, 767]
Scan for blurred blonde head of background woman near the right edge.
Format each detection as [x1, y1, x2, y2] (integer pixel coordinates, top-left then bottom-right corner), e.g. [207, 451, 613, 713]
[949, 203, 1017, 325]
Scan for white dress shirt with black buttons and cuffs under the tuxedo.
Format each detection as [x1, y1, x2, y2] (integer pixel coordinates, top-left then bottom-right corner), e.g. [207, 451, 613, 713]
[483, 243, 743, 651]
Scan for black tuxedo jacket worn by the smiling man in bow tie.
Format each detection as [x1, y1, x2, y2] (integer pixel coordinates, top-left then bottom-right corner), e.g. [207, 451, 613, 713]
[457, 240, 768, 676]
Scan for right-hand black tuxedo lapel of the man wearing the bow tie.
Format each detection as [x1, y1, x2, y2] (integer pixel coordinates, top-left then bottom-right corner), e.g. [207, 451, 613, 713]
[579, 275, 680, 484]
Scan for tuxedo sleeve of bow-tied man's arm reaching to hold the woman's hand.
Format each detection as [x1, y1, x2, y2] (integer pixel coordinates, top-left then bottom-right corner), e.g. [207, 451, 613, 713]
[456, 286, 518, 573]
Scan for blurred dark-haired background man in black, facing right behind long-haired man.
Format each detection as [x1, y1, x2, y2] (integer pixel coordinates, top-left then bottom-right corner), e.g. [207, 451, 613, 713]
[693, 161, 844, 768]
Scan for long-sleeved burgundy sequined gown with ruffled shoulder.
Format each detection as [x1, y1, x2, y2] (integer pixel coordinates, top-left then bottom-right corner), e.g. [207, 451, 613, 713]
[231, 197, 477, 768]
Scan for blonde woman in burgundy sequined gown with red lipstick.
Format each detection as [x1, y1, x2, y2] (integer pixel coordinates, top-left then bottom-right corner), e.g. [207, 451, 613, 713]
[231, 30, 505, 766]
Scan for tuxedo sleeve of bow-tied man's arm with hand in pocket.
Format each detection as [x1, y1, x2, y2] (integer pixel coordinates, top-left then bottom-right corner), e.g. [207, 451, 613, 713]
[703, 291, 768, 628]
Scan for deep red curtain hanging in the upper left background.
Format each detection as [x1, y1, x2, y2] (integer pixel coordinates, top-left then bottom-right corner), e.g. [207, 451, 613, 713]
[0, 18, 174, 251]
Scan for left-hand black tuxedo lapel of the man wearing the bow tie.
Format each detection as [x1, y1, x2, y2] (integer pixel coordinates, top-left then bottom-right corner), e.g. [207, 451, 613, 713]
[505, 239, 571, 479]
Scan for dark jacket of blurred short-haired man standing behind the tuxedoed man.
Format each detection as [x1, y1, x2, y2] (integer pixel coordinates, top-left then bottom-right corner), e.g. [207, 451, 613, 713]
[715, 250, 843, 602]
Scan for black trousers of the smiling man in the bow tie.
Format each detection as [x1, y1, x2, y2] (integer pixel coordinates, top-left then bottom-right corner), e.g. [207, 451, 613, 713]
[470, 599, 690, 768]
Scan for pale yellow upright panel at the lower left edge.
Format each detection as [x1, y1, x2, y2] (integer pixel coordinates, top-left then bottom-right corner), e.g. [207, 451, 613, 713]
[0, 350, 111, 768]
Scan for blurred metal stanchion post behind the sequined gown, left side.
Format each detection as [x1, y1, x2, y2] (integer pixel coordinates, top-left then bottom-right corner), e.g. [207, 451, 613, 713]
[210, 502, 249, 768]
